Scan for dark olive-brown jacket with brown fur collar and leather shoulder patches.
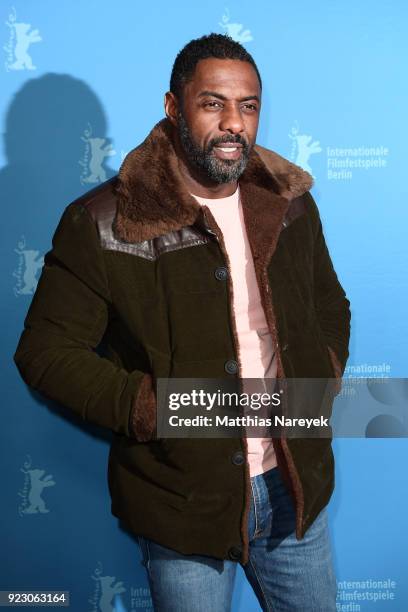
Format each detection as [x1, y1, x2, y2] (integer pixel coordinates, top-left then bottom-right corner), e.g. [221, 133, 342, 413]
[14, 119, 350, 564]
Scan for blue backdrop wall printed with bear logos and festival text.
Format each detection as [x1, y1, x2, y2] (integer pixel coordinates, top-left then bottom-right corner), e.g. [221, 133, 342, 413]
[0, 0, 408, 612]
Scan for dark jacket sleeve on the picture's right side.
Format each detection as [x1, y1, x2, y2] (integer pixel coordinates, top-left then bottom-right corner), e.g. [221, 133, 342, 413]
[306, 192, 351, 377]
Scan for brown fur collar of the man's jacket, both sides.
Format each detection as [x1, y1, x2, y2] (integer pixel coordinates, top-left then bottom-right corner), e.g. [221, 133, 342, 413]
[113, 118, 313, 242]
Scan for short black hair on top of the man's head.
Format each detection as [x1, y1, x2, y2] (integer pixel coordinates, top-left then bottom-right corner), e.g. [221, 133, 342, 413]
[170, 33, 262, 100]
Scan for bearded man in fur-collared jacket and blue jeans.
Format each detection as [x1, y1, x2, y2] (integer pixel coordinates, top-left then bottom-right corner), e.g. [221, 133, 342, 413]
[15, 34, 350, 612]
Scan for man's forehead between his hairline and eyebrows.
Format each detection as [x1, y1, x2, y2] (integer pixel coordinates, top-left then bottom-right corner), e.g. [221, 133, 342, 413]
[184, 58, 261, 97]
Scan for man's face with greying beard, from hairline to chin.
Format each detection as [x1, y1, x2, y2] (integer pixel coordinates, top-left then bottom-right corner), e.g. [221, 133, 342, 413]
[173, 58, 261, 183]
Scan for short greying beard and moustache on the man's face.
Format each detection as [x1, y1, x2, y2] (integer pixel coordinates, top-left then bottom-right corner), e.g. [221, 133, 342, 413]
[177, 111, 251, 183]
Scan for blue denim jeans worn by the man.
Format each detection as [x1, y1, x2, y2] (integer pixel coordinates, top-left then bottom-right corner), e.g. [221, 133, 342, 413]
[139, 467, 336, 612]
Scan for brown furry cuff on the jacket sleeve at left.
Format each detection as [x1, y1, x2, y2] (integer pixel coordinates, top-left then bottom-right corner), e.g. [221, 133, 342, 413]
[129, 373, 157, 442]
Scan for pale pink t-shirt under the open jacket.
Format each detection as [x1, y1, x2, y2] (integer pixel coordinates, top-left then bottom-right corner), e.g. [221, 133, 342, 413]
[191, 186, 277, 476]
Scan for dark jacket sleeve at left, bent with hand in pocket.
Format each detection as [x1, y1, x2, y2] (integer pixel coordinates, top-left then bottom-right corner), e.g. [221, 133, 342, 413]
[14, 203, 156, 441]
